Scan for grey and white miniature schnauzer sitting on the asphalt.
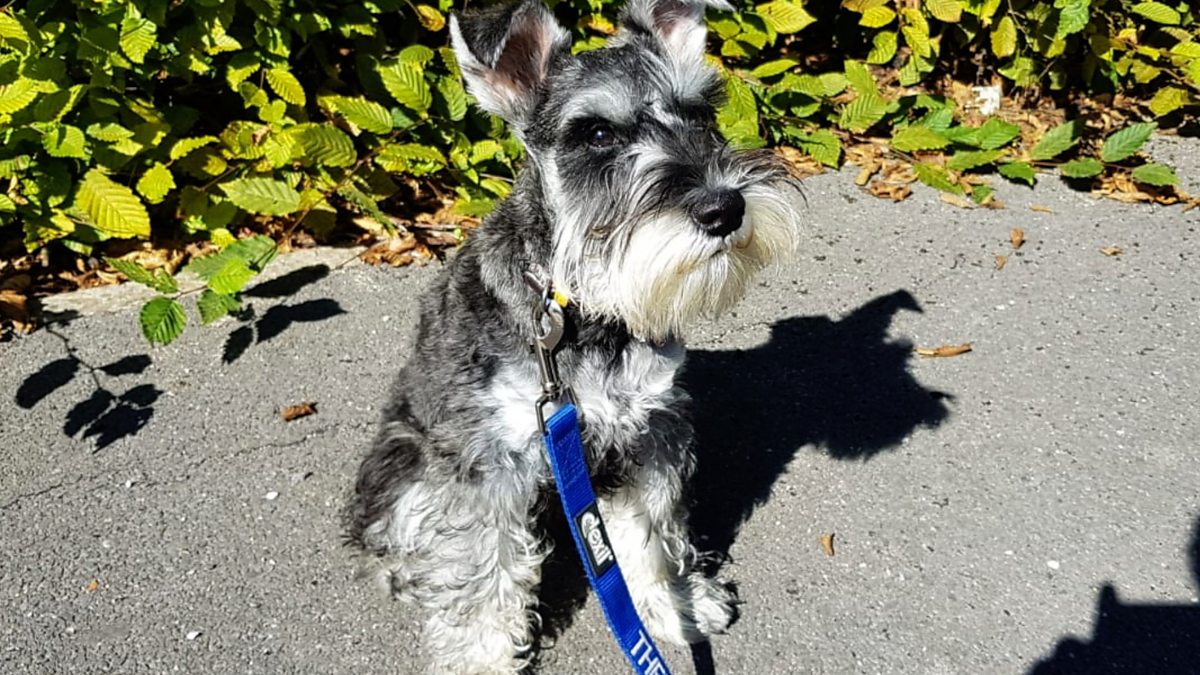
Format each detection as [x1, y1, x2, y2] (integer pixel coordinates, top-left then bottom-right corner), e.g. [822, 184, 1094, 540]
[347, 0, 799, 674]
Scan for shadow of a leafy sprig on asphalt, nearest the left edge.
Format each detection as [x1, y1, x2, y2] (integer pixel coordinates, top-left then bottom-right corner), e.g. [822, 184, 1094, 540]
[16, 327, 162, 450]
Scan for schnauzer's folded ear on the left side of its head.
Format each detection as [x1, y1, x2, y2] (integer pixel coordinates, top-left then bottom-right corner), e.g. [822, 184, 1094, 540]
[450, 0, 571, 129]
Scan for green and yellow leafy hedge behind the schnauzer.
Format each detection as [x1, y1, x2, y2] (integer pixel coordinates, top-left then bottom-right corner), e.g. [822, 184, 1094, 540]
[0, 0, 1200, 341]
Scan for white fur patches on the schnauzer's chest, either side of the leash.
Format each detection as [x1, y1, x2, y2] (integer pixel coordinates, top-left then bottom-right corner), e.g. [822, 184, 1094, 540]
[487, 342, 684, 449]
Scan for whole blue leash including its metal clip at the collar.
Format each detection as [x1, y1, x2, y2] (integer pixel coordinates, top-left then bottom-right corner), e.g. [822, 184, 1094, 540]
[524, 273, 671, 675]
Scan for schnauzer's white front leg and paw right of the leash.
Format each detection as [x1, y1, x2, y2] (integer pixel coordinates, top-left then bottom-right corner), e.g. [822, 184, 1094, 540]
[600, 458, 737, 645]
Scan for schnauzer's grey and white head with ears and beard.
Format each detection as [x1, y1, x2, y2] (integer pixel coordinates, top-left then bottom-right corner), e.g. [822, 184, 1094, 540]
[450, 0, 798, 341]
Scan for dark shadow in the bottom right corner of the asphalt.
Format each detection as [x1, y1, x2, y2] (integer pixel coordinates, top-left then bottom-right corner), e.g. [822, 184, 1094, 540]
[1030, 511, 1200, 675]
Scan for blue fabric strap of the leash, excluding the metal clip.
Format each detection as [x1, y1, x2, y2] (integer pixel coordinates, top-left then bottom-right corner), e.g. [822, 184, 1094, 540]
[546, 402, 671, 675]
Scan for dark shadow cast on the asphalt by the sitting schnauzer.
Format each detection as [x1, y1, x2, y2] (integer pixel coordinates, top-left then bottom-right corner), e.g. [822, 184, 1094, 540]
[540, 291, 950, 673]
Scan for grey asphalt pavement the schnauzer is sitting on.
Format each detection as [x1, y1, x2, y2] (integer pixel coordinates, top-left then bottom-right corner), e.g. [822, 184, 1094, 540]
[0, 139, 1200, 675]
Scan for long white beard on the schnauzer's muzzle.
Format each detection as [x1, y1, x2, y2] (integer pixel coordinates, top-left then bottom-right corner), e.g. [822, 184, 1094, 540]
[554, 184, 798, 342]
